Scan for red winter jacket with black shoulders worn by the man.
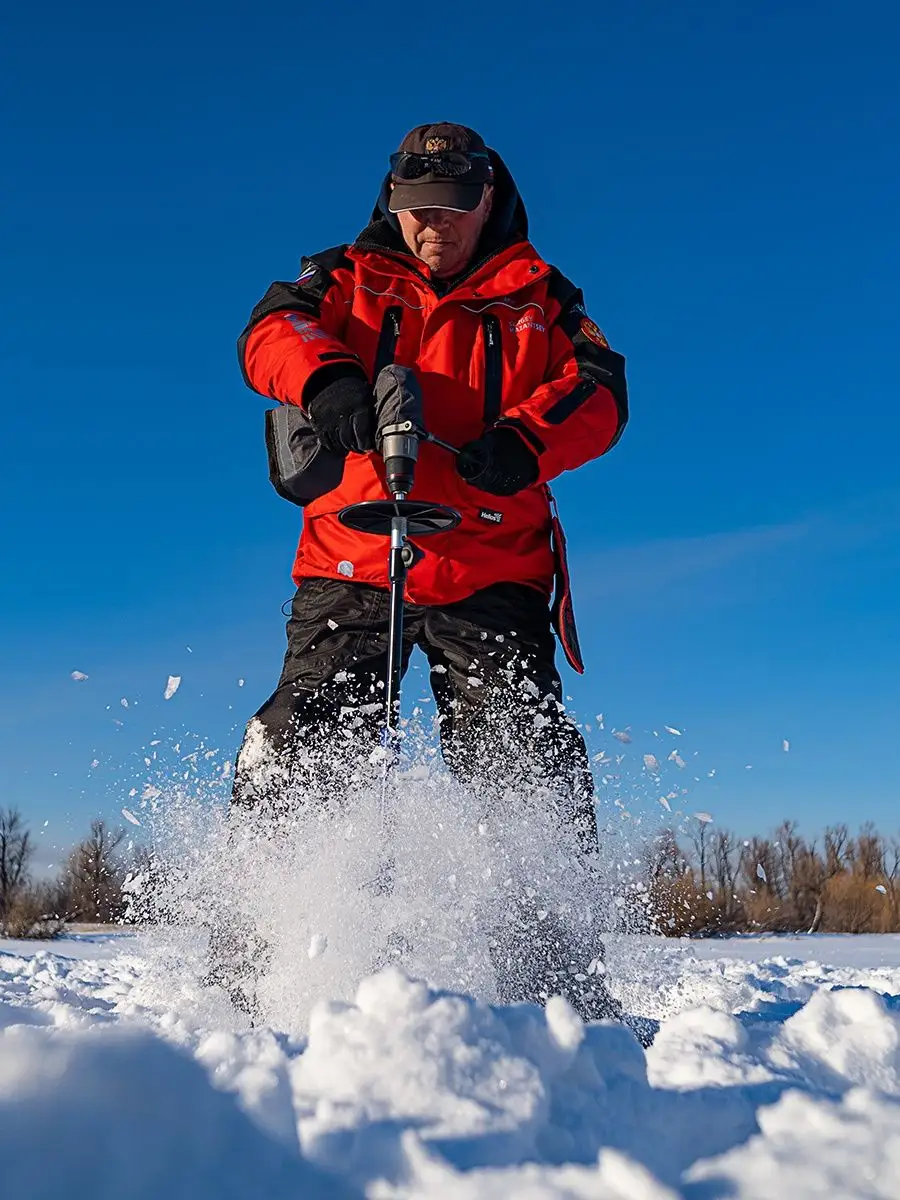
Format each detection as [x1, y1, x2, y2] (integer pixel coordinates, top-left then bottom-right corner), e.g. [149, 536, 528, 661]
[239, 176, 628, 605]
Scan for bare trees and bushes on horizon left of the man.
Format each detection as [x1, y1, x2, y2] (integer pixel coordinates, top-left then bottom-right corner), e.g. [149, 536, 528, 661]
[0, 808, 130, 937]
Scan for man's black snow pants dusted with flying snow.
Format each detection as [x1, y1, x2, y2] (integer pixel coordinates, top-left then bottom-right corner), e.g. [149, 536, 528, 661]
[233, 578, 598, 854]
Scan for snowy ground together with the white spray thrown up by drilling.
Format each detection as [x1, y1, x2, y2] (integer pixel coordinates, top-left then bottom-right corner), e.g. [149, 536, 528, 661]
[0, 712, 900, 1200]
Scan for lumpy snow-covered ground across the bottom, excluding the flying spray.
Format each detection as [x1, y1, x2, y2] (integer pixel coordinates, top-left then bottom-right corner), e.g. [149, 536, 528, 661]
[0, 934, 900, 1200]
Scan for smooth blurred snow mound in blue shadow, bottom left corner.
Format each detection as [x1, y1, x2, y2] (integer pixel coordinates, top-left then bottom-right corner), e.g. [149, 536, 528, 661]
[0, 1025, 331, 1200]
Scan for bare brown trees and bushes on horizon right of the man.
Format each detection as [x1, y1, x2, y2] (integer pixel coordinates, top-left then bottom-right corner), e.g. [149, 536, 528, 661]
[632, 814, 900, 937]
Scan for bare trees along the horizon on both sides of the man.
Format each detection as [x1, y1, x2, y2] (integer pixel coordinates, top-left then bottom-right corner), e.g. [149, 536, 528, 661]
[0, 808, 900, 937]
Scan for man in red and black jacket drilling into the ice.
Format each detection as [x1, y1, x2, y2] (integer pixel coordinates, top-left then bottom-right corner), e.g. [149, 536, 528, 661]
[234, 124, 628, 1017]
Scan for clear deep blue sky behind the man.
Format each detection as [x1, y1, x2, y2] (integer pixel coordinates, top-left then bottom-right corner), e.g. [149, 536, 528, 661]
[0, 0, 900, 853]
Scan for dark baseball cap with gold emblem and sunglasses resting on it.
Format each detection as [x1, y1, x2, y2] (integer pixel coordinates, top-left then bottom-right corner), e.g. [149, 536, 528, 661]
[388, 121, 493, 212]
